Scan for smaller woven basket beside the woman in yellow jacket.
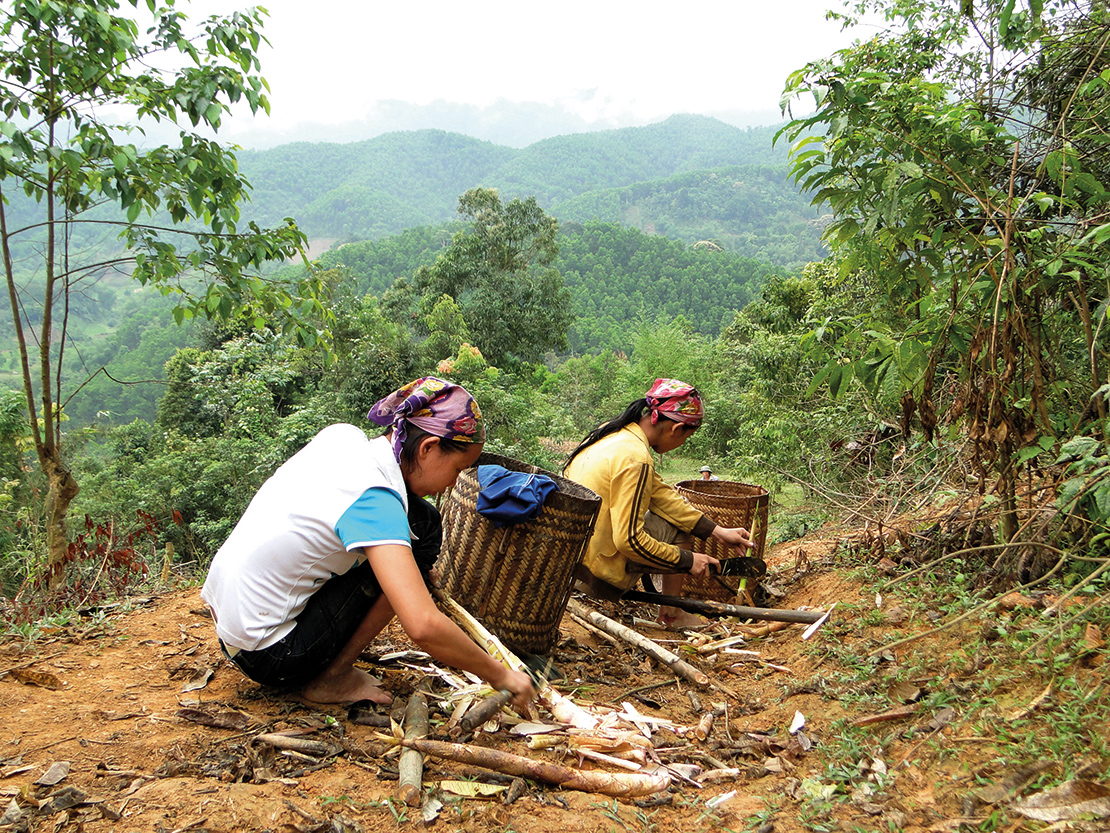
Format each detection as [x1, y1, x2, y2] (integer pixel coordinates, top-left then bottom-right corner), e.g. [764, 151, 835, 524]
[675, 480, 770, 603]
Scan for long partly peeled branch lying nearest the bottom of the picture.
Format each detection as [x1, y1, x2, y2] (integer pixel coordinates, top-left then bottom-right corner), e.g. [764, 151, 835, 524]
[389, 737, 670, 797]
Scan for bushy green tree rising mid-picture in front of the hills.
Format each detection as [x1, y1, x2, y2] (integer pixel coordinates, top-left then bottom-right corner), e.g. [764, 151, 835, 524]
[401, 188, 572, 365]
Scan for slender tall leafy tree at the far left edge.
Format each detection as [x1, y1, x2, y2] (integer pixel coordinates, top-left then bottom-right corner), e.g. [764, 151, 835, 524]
[0, 0, 319, 584]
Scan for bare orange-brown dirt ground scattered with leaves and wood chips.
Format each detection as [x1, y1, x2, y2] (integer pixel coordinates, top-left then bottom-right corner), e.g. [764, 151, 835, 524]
[0, 528, 1083, 833]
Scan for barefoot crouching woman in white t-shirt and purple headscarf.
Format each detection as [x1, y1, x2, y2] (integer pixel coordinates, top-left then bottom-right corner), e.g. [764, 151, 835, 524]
[201, 377, 535, 707]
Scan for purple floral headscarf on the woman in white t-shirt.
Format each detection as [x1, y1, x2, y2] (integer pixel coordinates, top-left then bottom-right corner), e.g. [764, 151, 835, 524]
[366, 377, 485, 460]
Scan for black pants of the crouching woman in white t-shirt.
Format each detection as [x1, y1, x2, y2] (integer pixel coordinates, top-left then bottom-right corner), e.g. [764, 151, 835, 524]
[220, 493, 443, 689]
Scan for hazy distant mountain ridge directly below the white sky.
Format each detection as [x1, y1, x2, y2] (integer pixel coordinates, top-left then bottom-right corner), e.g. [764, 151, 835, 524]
[238, 116, 820, 264]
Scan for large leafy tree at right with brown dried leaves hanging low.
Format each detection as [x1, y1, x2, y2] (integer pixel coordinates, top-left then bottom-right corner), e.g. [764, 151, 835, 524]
[784, 0, 1110, 539]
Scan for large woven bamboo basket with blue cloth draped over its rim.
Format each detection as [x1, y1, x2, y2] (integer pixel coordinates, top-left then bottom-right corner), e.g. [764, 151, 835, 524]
[437, 453, 602, 654]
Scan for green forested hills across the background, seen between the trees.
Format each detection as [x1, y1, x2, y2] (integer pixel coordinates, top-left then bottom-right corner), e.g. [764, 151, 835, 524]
[0, 117, 826, 425]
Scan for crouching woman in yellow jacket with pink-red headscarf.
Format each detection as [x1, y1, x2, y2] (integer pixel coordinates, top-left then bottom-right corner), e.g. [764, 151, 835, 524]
[564, 379, 754, 629]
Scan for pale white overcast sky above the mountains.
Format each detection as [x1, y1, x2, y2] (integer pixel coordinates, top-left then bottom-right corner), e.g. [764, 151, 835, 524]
[185, 0, 861, 147]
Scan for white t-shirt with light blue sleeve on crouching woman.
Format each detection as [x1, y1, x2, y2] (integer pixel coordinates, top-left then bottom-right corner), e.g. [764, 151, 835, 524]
[201, 424, 412, 651]
